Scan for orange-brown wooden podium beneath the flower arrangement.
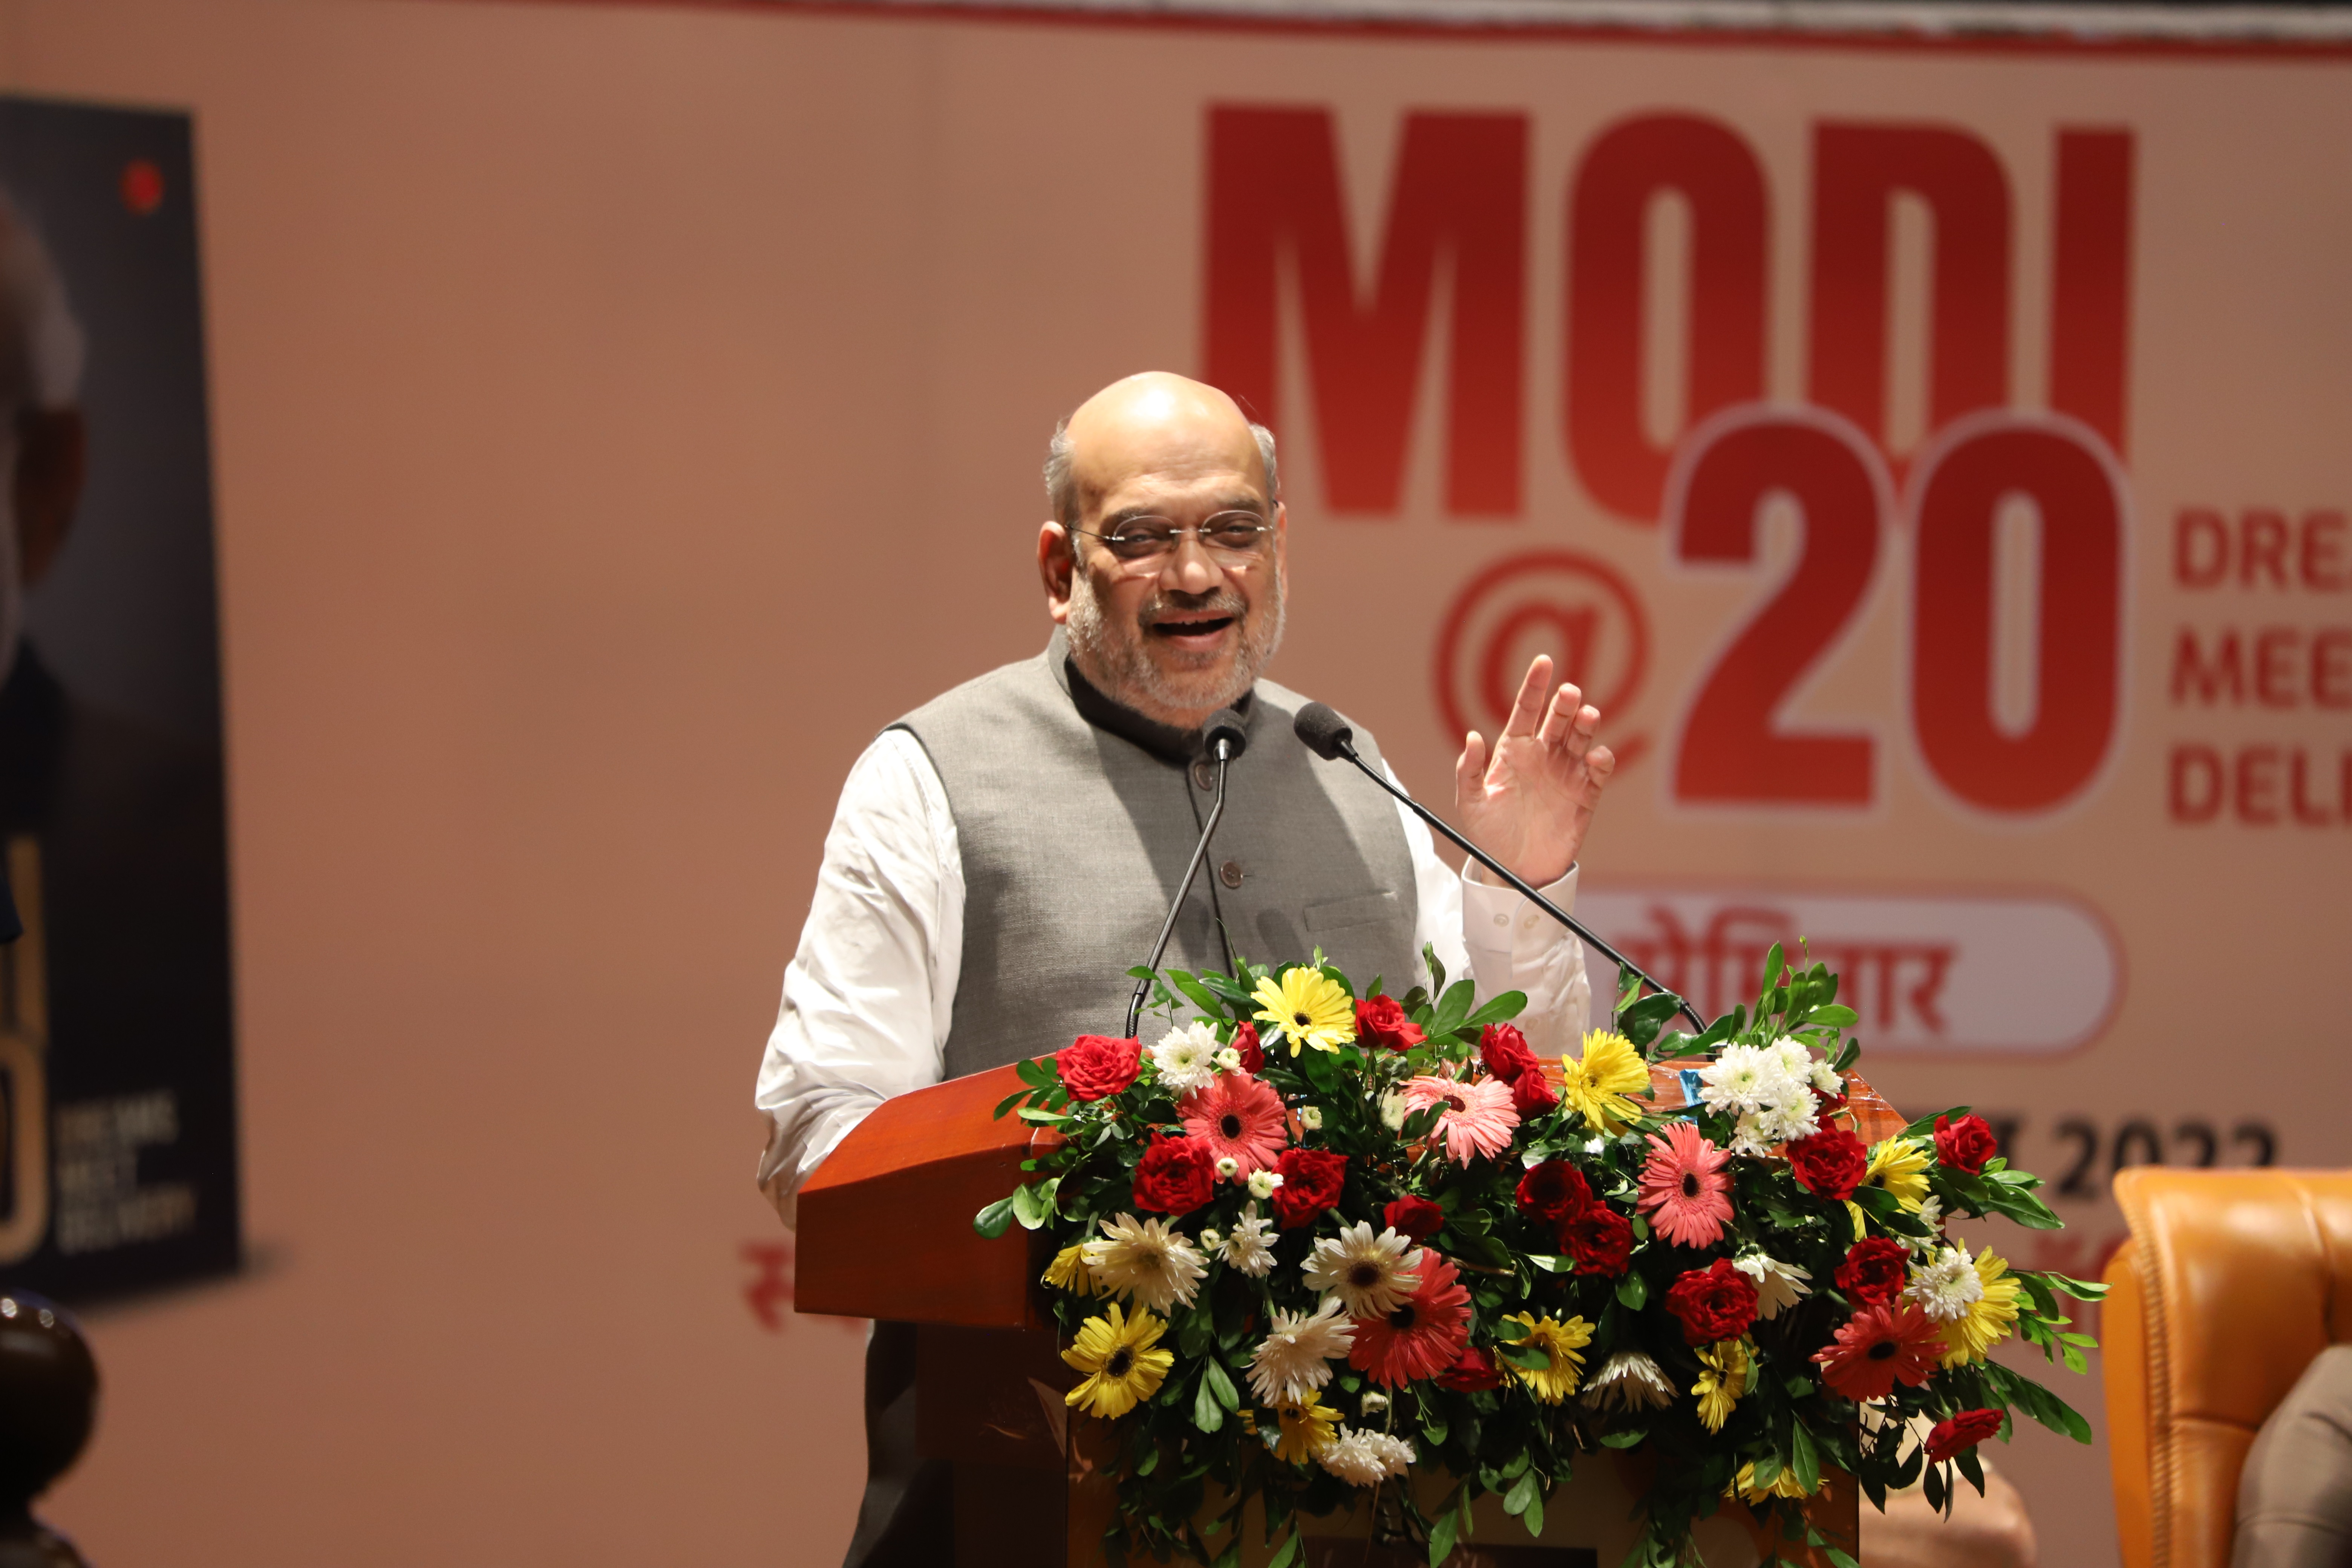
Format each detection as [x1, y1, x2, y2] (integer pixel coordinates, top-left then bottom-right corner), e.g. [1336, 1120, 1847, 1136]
[795, 1067, 1903, 1568]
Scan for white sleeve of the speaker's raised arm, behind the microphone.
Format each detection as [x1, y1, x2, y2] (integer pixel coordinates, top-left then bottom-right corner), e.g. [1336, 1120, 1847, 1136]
[1383, 764, 1592, 1055]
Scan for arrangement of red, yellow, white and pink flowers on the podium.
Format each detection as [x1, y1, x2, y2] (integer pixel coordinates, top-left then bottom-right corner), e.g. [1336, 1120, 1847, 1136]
[974, 947, 2105, 1568]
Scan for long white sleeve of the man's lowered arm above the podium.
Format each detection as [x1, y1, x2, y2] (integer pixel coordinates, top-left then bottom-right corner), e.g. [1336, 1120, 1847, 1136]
[757, 729, 964, 1225]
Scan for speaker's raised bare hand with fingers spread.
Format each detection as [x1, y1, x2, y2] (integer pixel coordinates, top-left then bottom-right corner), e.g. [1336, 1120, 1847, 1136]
[1453, 654, 1616, 886]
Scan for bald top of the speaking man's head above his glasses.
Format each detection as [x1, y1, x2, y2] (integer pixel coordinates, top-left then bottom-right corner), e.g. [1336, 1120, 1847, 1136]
[1044, 371, 1282, 529]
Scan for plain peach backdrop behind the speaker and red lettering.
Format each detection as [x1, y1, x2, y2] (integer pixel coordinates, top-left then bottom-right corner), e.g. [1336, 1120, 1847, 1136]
[0, 0, 2352, 1568]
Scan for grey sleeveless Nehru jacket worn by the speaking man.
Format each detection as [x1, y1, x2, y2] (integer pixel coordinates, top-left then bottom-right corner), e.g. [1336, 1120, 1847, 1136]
[894, 630, 1428, 1076]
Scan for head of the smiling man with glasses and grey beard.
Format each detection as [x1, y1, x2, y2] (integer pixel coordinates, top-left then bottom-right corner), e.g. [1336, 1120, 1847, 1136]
[1037, 371, 1284, 729]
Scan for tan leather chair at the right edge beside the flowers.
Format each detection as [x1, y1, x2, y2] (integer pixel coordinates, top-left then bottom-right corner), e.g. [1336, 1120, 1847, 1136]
[2100, 1166, 2352, 1568]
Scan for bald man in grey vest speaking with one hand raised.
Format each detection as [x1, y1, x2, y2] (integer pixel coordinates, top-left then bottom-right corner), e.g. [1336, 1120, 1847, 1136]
[757, 371, 1614, 1568]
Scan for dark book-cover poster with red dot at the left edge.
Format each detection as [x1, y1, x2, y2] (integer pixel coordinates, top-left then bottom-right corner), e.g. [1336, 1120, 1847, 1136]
[0, 99, 237, 1302]
